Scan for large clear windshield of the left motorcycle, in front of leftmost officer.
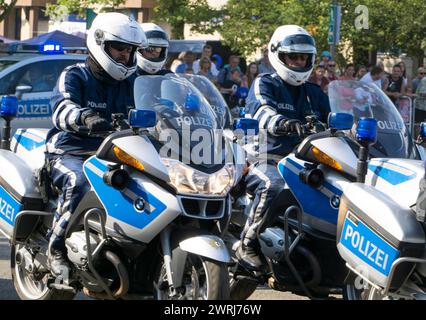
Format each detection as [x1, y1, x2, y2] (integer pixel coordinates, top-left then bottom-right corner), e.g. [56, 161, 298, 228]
[134, 74, 224, 171]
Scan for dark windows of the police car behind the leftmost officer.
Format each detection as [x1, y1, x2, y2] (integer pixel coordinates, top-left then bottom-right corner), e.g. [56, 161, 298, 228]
[0, 59, 81, 94]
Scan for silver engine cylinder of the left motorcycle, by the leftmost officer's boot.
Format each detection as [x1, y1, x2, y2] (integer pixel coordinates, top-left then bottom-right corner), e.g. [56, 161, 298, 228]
[65, 231, 99, 267]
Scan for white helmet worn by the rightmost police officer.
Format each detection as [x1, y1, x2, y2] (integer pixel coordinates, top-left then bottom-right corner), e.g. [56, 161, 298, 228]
[268, 25, 317, 86]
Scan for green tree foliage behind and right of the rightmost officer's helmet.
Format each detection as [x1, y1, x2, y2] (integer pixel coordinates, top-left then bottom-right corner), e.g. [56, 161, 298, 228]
[219, 0, 426, 58]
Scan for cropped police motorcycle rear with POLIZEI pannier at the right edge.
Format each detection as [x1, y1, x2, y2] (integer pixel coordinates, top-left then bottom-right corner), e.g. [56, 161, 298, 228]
[337, 113, 426, 300]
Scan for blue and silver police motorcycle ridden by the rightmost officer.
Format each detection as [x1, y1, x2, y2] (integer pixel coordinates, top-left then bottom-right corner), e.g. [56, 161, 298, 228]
[224, 81, 424, 299]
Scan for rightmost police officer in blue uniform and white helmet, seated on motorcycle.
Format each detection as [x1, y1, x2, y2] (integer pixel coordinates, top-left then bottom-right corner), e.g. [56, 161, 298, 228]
[236, 25, 330, 270]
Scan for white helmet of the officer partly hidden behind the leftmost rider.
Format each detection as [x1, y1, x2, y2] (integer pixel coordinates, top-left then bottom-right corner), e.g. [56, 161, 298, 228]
[137, 22, 169, 73]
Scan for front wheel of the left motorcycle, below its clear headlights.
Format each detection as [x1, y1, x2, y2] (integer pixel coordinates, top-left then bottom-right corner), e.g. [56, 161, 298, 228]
[154, 254, 229, 300]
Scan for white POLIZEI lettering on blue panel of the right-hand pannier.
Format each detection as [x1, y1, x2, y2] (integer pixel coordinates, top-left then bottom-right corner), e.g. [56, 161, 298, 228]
[344, 225, 389, 271]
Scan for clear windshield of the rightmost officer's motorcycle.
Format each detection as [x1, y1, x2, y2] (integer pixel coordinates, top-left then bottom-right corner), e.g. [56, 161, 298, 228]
[328, 80, 419, 159]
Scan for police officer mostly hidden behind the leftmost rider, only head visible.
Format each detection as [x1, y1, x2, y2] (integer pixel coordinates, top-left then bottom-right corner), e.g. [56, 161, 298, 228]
[137, 23, 172, 76]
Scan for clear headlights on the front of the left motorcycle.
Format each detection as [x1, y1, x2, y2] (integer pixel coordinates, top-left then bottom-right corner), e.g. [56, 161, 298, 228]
[161, 158, 235, 195]
